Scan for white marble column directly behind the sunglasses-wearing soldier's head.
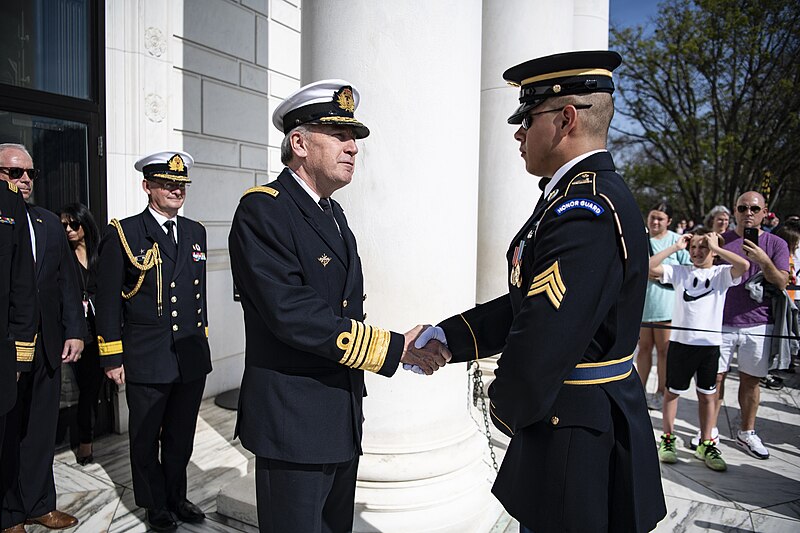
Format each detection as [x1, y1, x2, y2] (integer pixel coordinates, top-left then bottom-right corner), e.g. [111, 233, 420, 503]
[476, 0, 608, 385]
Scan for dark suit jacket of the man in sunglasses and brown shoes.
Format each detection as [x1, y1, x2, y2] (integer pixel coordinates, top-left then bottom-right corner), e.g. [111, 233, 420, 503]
[28, 205, 88, 368]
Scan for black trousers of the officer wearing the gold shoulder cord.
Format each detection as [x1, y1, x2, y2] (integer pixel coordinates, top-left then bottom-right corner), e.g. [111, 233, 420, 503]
[125, 377, 206, 509]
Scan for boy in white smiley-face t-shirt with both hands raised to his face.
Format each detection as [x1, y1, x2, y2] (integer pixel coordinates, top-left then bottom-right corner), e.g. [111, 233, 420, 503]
[650, 228, 750, 472]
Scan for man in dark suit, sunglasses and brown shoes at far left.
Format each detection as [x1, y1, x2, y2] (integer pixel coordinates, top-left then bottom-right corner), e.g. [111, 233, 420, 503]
[0, 144, 86, 531]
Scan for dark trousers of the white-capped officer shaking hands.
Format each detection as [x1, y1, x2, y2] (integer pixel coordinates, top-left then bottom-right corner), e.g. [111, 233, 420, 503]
[256, 455, 359, 533]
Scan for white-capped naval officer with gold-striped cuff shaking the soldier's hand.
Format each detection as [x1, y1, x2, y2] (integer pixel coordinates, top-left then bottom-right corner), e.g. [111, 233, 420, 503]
[229, 80, 445, 533]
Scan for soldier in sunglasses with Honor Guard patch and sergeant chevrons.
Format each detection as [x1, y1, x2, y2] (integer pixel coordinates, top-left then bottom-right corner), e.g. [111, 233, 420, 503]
[417, 51, 666, 533]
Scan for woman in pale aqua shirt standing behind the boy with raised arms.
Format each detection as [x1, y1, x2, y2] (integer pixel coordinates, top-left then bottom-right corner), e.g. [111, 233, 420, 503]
[636, 202, 691, 411]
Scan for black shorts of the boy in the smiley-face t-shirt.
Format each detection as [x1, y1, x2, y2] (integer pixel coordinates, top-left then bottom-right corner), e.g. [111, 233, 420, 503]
[667, 341, 719, 395]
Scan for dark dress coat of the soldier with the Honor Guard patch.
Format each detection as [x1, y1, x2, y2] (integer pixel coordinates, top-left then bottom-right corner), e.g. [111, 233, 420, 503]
[440, 152, 666, 532]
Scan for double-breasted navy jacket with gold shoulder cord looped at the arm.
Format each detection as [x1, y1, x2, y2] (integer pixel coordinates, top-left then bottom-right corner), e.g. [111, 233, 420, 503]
[95, 208, 211, 384]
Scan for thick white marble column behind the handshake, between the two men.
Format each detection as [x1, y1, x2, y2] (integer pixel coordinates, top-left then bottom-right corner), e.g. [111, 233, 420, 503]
[301, 0, 500, 532]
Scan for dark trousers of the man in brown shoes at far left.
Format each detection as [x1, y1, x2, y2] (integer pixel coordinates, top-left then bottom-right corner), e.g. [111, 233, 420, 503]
[0, 341, 61, 528]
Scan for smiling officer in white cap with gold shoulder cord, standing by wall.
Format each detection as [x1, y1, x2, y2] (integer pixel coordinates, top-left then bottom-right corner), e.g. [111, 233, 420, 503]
[96, 152, 211, 531]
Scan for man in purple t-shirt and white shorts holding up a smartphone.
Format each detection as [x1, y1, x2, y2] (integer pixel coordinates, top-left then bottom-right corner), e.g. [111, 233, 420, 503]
[717, 191, 789, 459]
